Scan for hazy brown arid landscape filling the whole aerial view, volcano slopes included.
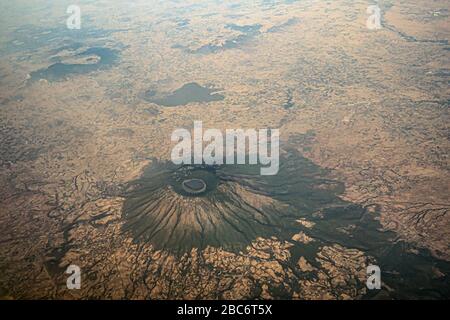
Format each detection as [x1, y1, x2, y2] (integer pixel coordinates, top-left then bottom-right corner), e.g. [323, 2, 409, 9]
[0, 0, 450, 299]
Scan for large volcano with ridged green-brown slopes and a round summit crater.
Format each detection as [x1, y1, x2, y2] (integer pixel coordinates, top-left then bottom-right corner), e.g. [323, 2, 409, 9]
[123, 150, 342, 252]
